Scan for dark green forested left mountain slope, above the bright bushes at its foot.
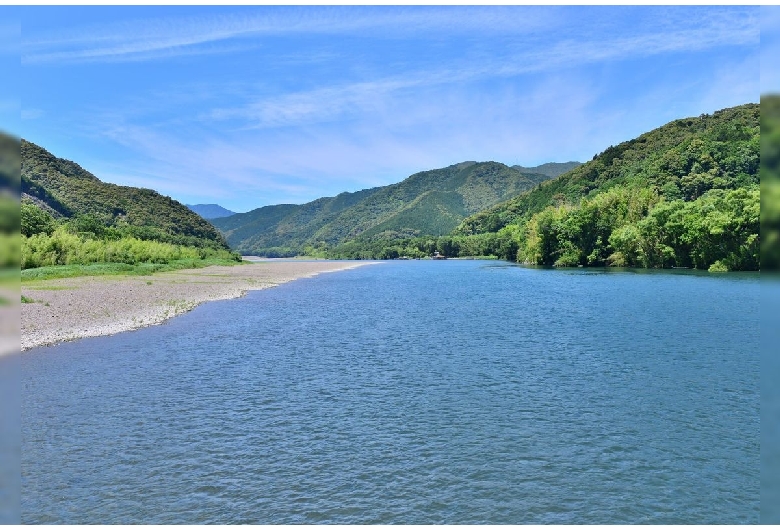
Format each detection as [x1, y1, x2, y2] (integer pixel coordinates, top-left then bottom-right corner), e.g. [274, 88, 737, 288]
[21, 140, 228, 249]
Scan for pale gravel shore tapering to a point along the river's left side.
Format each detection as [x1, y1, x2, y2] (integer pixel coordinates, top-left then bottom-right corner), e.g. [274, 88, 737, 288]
[17, 260, 378, 351]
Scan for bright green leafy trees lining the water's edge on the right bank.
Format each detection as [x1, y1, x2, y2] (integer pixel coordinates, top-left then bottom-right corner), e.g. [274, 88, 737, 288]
[517, 186, 760, 270]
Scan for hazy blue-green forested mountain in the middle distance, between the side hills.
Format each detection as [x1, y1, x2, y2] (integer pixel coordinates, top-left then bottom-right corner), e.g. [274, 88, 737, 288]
[212, 162, 549, 256]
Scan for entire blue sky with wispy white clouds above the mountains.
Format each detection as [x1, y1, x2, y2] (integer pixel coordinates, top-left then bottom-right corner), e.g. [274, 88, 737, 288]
[10, 6, 762, 211]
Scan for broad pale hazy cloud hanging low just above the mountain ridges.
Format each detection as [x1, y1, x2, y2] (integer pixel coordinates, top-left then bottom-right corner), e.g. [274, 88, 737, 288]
[77, 72, 611, 209]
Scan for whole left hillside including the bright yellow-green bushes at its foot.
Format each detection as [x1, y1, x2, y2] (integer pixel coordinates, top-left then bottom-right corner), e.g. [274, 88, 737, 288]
[22, 140, 240, 270]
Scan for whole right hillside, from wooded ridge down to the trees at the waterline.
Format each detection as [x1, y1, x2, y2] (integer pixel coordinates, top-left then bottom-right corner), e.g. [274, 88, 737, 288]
[453, 104, 761, 270]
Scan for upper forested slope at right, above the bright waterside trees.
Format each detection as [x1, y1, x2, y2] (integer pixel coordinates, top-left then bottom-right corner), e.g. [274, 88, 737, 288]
[456, 104, 760, 235]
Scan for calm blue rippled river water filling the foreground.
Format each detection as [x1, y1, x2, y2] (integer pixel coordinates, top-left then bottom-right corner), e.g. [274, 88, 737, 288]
[21, 261, 761, 524]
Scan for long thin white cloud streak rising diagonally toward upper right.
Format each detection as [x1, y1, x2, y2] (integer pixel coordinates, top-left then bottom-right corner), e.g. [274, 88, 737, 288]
[201, 8, 760, 128]
